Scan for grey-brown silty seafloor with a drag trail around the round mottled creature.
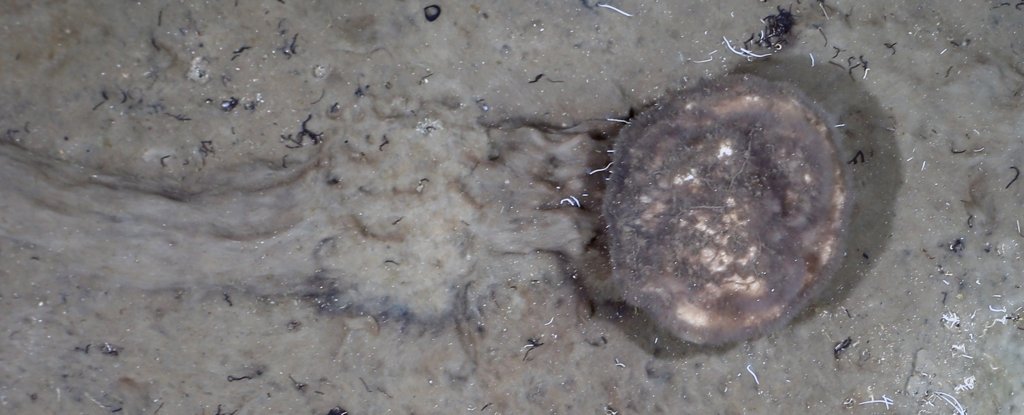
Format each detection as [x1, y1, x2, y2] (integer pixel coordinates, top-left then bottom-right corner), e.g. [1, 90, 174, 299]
[0, 0, 1024, 414]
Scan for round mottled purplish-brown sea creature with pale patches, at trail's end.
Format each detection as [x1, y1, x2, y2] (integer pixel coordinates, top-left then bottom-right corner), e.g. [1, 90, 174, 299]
[604, 76, 848, 344]
